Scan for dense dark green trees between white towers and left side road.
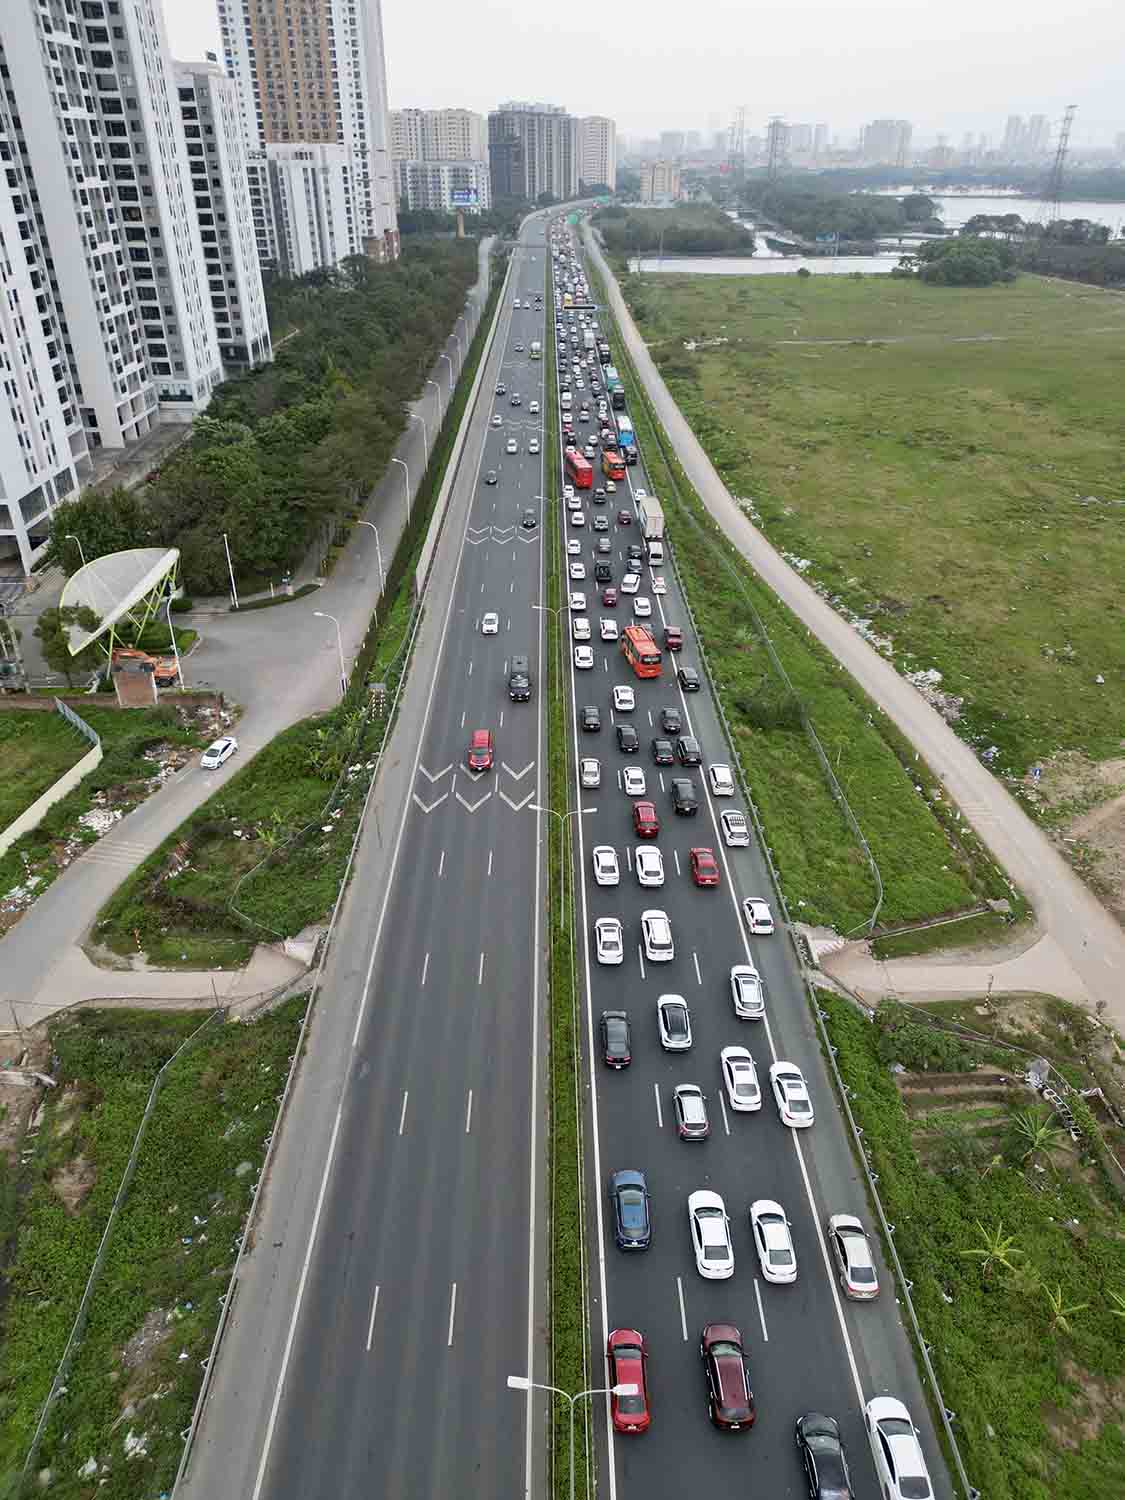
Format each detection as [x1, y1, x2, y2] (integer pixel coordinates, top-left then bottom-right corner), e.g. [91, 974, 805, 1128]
[47, 240, 477, 594]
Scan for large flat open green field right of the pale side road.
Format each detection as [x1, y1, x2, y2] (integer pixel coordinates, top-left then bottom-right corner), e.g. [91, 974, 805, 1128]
[624, 276, 1125, 777]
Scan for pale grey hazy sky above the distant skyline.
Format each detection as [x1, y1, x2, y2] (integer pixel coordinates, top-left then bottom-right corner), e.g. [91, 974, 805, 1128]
[164, 0, 1125, 146]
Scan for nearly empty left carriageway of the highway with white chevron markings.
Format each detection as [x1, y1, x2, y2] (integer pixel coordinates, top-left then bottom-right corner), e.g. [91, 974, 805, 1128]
[243, 219, 546, 1500]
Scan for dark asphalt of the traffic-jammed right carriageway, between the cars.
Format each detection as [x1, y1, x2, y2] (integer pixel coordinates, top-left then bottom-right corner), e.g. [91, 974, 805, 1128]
[549, 225, 953, 1500]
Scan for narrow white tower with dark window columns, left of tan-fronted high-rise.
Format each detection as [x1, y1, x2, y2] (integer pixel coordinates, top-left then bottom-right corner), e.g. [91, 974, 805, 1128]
[176, 62, 273, 374]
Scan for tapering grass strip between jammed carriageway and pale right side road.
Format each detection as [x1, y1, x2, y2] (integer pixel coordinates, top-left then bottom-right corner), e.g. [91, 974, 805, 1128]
[591, 259, 1022, 932]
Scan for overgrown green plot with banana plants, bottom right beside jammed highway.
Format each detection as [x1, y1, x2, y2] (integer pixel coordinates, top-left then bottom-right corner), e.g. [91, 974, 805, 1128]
[821, 993, 1125, 1500]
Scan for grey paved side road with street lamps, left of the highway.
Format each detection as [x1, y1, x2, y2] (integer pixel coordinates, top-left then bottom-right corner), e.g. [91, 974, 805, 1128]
[0, 242, 491, 1026]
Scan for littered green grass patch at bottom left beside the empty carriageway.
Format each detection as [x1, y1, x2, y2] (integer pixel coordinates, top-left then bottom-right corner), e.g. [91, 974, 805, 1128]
[0, 998, 305, 1500]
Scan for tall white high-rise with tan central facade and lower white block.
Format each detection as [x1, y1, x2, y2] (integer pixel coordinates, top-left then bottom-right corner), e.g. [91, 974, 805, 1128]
[218, 0, 399, 276]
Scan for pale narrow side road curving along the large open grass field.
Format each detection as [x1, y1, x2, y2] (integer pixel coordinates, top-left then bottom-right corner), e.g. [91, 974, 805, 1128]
[582, 225, 1125, 1026]
